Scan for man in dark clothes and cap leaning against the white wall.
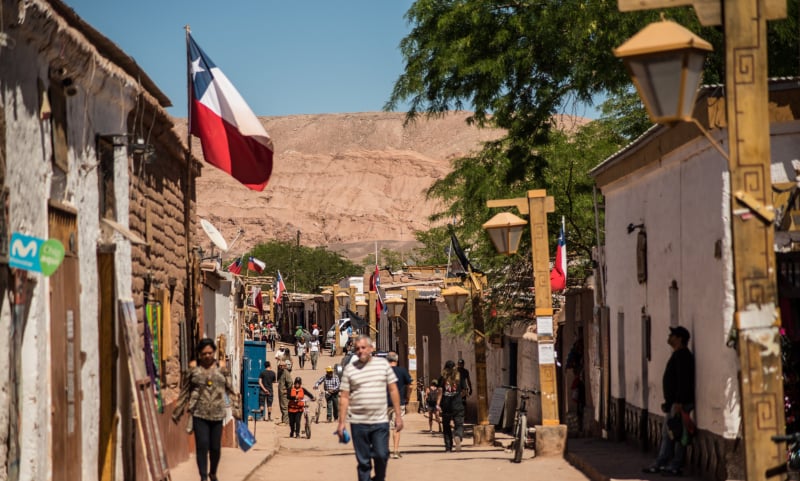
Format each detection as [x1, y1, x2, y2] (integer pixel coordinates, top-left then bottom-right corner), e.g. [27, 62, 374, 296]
[644, 326, 694, 476]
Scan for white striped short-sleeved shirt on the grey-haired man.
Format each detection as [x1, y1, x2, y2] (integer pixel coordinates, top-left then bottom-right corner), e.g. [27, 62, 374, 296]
[340, 357, 397, 424]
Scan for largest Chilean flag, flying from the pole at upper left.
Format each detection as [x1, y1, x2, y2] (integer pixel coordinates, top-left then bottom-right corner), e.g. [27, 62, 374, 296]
[188, 35, 273, 191]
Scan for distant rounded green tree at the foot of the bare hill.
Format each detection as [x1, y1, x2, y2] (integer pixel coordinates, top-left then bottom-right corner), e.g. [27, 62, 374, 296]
[234, 240, 364, 293]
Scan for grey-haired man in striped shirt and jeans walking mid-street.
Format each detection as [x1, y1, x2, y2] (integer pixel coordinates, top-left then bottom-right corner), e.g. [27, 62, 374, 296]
[336, 335, 403, 481]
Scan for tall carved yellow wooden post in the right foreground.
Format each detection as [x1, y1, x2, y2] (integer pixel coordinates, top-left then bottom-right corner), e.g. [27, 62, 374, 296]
[617, 0, 786, 480]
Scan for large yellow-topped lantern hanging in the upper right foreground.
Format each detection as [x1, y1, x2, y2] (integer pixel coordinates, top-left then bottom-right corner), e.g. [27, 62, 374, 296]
[614, 19, 712, 124]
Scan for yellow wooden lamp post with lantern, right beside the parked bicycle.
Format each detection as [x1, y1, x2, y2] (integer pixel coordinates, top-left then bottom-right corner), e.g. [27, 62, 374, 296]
[483, 190, 566, 451]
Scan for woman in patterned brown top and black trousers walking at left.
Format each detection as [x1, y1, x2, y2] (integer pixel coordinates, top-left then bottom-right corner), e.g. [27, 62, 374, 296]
[172, 338, 241, 481]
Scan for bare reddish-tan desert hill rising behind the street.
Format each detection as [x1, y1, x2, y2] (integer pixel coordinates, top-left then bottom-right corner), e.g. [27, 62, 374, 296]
[176, 112, 582, 261]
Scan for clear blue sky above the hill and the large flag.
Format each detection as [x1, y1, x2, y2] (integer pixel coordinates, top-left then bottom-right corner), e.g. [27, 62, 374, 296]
[65, 0, 413, 117]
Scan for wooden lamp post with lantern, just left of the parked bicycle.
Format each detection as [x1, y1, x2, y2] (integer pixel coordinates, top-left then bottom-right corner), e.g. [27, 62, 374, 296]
[442, 280, 494, 446]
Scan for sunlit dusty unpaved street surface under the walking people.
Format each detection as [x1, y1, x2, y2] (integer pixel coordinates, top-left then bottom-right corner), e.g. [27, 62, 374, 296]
[248, 348, 588, 481]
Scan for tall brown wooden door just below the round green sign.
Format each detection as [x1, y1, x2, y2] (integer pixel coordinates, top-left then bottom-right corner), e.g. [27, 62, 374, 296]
[49, 206, 81, 479]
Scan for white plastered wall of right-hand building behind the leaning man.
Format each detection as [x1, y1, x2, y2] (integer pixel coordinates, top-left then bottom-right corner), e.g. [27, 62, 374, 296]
[603, 123, 800, 438]
